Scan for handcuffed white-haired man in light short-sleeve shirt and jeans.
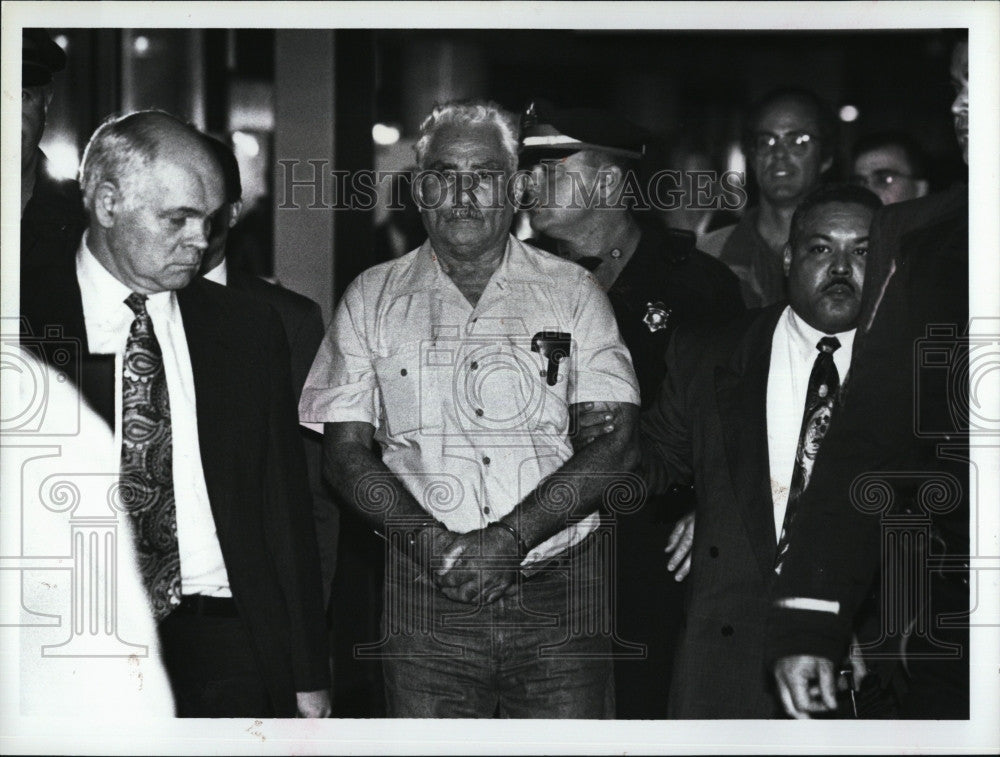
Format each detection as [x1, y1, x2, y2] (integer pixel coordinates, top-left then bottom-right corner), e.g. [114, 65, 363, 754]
[299, 101, 639, 718]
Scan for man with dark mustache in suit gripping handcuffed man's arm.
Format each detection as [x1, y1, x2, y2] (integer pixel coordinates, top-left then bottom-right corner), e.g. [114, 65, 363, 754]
[581, 186, 881, 718]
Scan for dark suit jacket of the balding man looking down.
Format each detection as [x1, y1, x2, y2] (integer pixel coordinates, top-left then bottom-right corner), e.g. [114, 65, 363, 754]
[21, 257, 329, 716]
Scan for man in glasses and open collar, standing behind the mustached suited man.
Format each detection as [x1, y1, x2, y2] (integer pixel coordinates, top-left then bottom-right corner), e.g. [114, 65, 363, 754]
[700, 89, 836, 307]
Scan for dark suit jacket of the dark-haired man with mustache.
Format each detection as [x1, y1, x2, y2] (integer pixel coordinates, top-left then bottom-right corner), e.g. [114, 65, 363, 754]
[642, 304, 784, 718]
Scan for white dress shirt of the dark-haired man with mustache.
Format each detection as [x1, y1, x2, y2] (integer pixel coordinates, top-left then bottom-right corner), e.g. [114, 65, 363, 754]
[767, 306, 855, 539]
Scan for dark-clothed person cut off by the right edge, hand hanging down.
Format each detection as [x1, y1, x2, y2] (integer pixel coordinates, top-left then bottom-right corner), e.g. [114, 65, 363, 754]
[769, 35, 972, 719]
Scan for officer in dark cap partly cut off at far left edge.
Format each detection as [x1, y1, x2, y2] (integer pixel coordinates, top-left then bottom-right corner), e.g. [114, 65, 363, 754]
[21, 29, 87, 268]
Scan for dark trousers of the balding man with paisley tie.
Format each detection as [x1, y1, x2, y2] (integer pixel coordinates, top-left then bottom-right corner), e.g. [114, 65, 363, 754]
[159, 597, 277, 718]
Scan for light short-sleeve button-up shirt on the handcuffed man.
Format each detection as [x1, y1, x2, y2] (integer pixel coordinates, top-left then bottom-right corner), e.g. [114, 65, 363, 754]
[299, 236, 639, 565]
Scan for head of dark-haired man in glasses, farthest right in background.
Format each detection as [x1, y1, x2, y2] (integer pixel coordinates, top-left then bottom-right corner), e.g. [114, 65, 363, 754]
[851, 132, 930, 205]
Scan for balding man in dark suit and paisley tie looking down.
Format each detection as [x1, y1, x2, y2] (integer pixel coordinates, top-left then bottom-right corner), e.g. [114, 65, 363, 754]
[21, 111, 330, 717]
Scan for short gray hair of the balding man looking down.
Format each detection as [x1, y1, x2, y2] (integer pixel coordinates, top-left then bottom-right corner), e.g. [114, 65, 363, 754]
[80, 110, 196, 211]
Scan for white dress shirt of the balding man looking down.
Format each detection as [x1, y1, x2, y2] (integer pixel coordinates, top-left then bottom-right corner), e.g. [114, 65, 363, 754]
[76, 235, 232, 597]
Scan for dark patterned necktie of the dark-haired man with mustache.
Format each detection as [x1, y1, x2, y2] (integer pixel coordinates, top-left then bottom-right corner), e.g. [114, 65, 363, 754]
[774, 336, 840, 573]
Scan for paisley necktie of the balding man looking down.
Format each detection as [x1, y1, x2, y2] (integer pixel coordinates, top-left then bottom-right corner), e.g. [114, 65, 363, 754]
[121, 293, 181, 620]
